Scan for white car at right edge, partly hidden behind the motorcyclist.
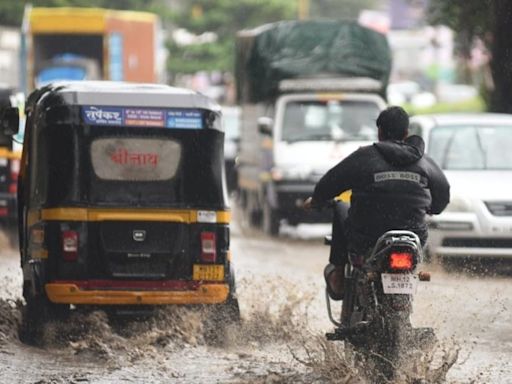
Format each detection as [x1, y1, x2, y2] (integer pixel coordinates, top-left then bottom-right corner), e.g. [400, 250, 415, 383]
[409, 113, 512, 259]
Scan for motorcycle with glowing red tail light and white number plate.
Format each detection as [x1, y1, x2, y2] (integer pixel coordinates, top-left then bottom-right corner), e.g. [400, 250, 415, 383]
[325, 226, 435, 381]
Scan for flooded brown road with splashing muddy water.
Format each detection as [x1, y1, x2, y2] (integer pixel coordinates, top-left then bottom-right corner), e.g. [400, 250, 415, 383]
[0, 222, 512, 384]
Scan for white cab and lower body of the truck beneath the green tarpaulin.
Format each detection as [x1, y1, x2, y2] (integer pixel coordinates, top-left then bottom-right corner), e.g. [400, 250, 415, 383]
[238, 80, 386, 235]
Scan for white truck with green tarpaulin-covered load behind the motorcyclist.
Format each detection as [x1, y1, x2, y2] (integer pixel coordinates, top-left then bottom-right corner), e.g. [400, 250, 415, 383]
[235, 20, 391, 236]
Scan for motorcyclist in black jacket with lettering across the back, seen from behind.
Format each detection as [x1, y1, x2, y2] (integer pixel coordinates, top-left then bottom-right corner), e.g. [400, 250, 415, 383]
[304, 107, 450, 300]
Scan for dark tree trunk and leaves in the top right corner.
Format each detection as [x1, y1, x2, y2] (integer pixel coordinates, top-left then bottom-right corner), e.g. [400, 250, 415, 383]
[429, 0, 512, 113]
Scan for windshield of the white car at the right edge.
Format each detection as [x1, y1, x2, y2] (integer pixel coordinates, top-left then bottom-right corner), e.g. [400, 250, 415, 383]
[428, 125, 512, 170]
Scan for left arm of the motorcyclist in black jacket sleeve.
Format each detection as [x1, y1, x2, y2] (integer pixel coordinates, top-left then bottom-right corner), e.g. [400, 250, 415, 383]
[313, 149, 362, 205]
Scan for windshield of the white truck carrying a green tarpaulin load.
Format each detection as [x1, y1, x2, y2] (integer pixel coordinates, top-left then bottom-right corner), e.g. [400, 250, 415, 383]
[282, 100, 379, 142]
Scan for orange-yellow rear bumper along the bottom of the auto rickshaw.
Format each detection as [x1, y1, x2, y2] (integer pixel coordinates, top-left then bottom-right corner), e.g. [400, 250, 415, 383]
[45, 283, 230, 305]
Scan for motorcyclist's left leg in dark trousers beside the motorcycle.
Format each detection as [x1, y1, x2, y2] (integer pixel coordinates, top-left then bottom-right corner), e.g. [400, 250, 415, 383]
[324, 202, 348, 300]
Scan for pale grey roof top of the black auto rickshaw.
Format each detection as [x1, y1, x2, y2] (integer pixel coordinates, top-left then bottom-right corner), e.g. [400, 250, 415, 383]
[41, 81, 220, 112]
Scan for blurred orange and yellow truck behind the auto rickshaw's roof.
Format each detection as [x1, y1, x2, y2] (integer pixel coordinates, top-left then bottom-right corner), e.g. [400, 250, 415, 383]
[20, 6, 163, 94]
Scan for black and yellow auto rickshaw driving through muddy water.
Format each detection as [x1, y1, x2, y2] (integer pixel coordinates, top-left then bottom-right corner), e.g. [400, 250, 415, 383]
[4, 81, 239, 342]
